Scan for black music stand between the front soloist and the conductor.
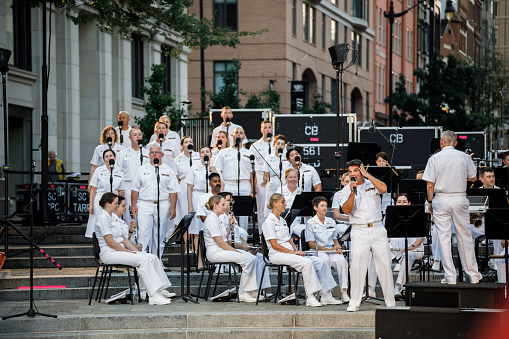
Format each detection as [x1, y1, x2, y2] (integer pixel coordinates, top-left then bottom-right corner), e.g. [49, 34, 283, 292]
[385, 205, 429, 294]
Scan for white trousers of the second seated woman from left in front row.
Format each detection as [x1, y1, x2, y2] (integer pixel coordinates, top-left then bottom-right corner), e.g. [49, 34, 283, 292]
[207, 249, 260, 293]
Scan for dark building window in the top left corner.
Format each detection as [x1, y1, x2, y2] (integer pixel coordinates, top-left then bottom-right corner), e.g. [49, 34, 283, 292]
[5, 0, 32, 71]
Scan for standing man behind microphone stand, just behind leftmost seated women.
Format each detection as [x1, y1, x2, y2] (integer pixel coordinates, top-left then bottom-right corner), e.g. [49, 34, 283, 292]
[131, 145, 180, 258]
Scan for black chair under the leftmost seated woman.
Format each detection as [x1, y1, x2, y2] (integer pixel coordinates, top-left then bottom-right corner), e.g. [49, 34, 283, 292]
[88, 232, 141, 305]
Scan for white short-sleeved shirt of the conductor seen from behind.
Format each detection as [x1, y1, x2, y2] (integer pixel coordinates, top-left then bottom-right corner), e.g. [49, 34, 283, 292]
[422, 146, 477, 193]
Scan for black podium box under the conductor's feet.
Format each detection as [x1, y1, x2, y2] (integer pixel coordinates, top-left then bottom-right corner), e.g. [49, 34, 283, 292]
[405, 281, 506, 309]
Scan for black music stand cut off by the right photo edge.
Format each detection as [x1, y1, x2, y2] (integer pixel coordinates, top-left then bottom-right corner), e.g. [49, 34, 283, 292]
[484, 208, 509, 283]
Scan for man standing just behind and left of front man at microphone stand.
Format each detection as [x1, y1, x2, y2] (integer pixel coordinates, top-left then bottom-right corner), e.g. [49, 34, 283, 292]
[117, 127, 150, 225]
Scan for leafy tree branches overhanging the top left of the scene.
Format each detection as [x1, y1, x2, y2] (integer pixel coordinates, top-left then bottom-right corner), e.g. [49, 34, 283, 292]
[30, 0, 266, 55]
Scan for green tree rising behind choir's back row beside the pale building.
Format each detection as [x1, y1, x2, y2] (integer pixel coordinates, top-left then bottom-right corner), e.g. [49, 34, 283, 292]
[134, 64, 186, 145]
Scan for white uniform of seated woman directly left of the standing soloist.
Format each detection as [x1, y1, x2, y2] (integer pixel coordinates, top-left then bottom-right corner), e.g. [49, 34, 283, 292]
[306, 215, 348, 290]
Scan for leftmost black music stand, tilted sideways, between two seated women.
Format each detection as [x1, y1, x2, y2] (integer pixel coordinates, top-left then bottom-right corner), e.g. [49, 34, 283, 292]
[166, 211, 199, 304]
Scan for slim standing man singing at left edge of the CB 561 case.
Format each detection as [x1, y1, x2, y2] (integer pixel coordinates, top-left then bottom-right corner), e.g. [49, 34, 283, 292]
[249, 120, 274, 232]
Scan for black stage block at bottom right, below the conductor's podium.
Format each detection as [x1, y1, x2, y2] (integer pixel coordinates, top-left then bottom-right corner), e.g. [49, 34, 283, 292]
[375, 307, 509, 339]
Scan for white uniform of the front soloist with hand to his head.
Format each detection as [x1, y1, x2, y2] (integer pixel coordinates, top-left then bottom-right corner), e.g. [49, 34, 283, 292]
[339, 178, 396, 307]
